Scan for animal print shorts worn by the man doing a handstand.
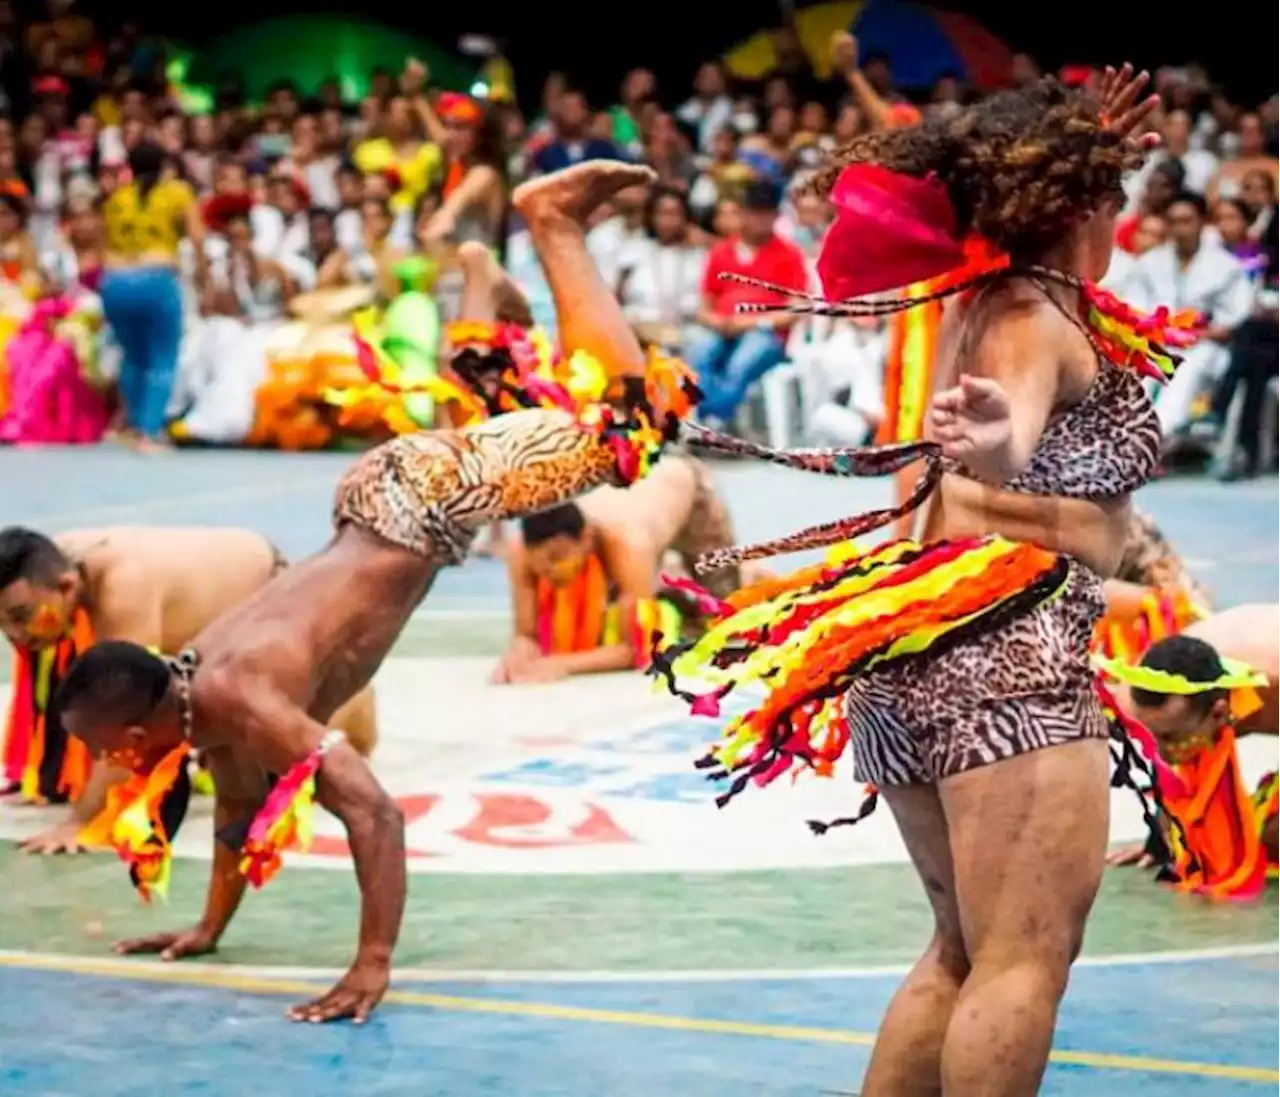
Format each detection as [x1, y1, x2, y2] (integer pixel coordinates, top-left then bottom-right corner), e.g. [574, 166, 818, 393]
[334, 408, 618, 565]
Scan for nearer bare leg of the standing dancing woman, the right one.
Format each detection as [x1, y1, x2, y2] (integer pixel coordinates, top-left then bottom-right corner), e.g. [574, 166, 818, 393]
[938, 739, 1110, 1097]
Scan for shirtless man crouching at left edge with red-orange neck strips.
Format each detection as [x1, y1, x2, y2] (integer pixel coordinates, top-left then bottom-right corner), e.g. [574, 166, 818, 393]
[0, 526, 378, 854]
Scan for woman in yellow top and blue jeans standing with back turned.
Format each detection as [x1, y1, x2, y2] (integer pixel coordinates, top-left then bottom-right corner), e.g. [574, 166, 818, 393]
[102, 142, 207, 448]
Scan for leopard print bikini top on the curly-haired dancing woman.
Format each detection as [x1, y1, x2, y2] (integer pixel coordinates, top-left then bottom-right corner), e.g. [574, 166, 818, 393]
[943, 287, 1162, 502]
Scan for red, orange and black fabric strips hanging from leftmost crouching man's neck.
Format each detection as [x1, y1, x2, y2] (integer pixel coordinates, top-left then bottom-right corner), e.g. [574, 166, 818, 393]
[0, 609, 95, 804]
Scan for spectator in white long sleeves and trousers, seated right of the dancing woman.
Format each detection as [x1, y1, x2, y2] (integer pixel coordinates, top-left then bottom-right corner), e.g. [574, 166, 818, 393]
[1129, 192, 1254, 442]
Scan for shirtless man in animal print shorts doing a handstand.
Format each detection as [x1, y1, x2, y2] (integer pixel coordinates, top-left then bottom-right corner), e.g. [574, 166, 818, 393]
[49, 161, 666, 1021]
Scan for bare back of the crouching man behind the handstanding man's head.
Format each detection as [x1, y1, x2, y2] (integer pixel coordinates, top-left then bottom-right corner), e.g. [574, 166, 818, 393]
[56, 526, 274, 652]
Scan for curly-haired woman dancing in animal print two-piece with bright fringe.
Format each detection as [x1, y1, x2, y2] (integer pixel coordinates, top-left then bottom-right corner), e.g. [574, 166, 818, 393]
[655, 70, 1188, 1097]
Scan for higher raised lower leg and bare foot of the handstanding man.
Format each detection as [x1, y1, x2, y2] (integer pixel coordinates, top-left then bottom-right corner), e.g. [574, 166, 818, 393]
[512, 160, 657, 378]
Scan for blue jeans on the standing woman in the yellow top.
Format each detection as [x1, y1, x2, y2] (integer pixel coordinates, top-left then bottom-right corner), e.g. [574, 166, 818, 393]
[102, 266, 183, 438]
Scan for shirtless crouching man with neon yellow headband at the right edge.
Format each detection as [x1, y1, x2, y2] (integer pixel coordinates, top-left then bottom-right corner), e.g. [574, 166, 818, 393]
[1107, 603, 1280, 868]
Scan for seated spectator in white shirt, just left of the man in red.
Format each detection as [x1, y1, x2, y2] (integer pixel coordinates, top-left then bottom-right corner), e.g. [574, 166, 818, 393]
[617, 187, 707, 353]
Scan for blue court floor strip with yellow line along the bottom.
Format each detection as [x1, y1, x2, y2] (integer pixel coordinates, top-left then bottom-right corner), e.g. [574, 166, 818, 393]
[0, 956, 1280, 1097]
